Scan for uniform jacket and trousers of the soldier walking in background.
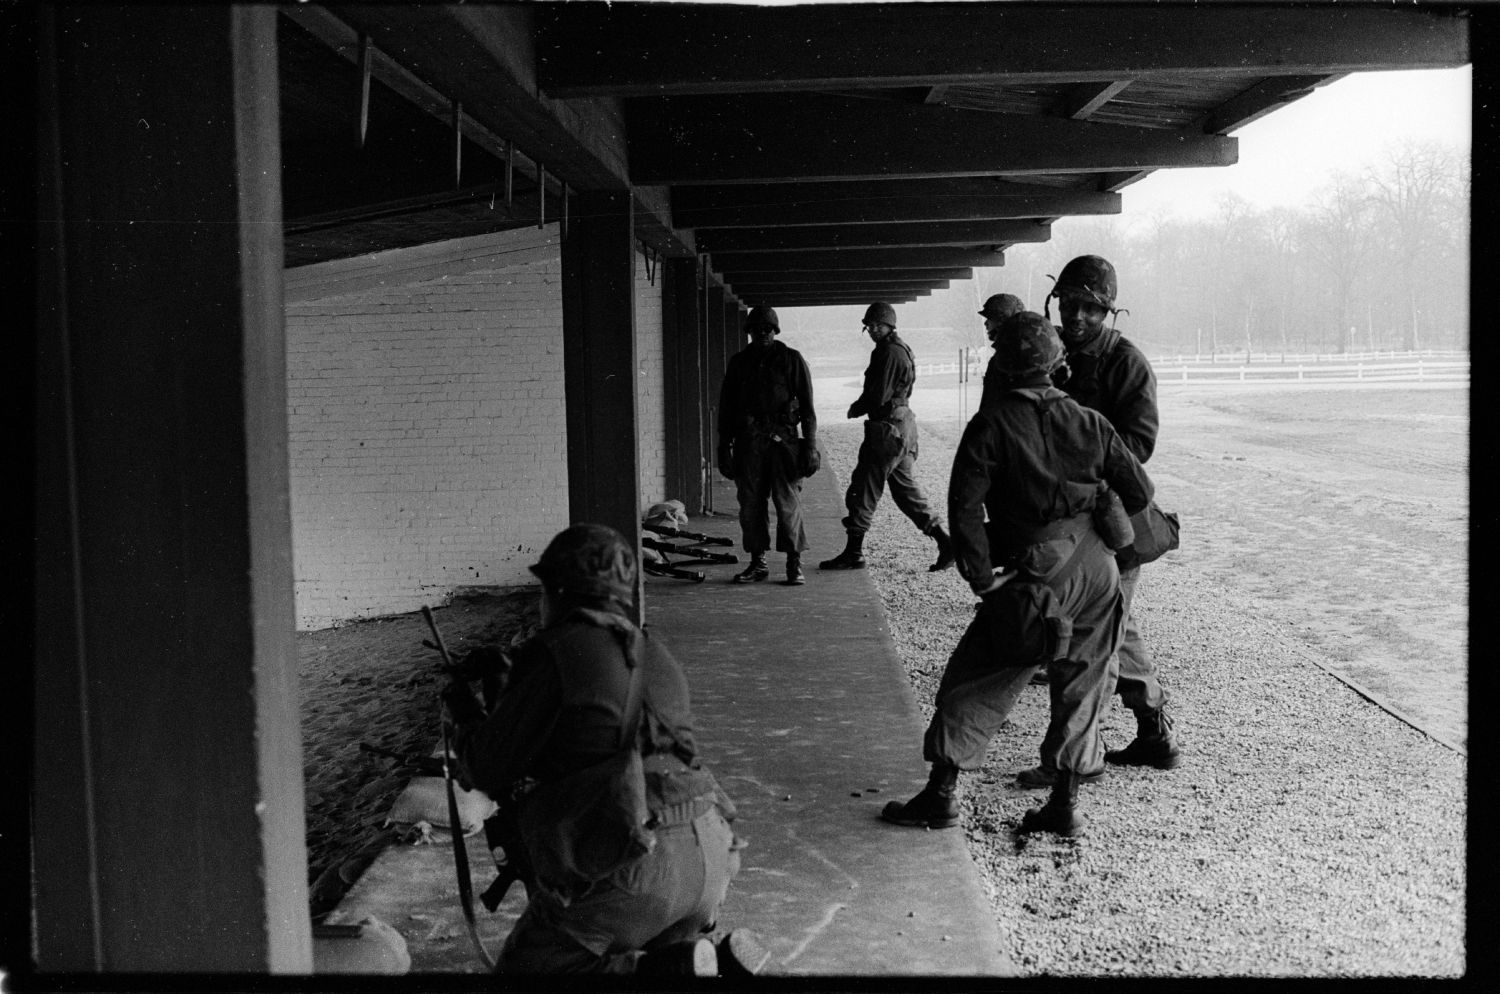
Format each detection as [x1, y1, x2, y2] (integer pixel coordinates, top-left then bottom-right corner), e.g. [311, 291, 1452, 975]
[843, 331, 942, 535]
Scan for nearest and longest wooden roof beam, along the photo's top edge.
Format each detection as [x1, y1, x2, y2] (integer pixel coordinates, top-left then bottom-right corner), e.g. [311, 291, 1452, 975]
[537, 3, 1469, 97]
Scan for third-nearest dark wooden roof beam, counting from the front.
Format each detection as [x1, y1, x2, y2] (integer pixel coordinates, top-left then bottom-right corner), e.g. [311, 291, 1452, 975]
[672, 177, 1121, 228]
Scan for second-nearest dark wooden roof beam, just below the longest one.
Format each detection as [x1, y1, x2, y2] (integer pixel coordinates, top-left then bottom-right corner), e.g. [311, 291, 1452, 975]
[629, 93, 1239, 184]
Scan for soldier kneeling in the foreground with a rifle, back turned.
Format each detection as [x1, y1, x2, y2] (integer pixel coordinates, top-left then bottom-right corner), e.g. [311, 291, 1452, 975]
[443, 525, 768, 976]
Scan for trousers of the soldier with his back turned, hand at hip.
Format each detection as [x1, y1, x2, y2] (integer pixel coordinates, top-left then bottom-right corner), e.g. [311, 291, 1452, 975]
[923, 532, 1125, 774]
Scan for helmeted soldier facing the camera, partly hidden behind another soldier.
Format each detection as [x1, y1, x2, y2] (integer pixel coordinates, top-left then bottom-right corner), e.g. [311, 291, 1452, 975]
[1017, 255, 1182, 787]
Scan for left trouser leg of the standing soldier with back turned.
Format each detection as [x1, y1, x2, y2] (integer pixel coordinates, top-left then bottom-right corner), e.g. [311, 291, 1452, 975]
[923, 613, 1040, 769]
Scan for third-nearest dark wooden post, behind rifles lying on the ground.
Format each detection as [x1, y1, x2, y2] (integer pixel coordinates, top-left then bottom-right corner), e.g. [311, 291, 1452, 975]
[662, 259, 713, 513]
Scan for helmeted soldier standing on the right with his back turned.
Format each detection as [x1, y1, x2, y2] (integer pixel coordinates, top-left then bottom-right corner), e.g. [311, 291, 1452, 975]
[882, 312, 1152, 835]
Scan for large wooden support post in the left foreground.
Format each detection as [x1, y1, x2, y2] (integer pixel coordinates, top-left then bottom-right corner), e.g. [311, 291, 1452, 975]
[32, 4, 312, 975]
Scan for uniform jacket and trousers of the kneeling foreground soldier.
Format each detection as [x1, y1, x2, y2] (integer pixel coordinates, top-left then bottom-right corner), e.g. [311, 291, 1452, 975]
[455, 609, 740, 973]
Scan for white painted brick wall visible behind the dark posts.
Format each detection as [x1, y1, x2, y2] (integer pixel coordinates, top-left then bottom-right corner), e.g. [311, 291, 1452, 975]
[287, 229, 564, 630]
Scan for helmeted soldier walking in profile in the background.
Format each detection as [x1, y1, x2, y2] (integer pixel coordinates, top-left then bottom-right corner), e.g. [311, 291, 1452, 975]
[818, 303, 953, 571]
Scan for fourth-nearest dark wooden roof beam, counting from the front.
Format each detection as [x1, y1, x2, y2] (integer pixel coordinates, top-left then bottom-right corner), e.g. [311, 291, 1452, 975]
[695, 220, 1052, 252]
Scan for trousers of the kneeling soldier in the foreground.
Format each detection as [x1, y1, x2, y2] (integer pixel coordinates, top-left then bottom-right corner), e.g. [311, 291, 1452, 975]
[497, 810, 740, 975]
